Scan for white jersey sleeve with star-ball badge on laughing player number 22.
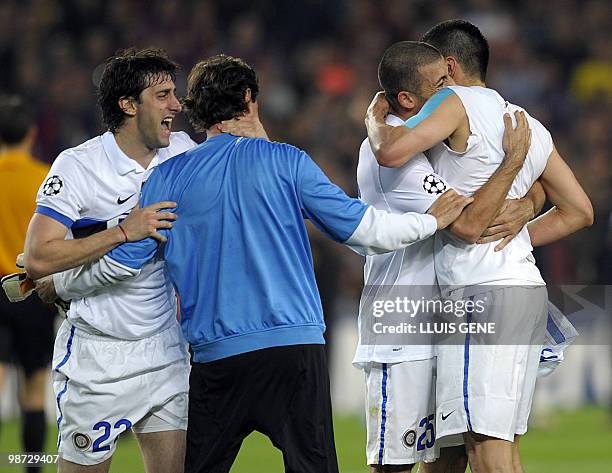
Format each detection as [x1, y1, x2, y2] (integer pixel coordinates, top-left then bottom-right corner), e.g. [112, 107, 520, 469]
[35, 150, 92, 228]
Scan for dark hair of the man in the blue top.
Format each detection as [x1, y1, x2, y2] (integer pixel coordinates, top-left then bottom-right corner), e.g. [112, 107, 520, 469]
[183, 54, 259, 131]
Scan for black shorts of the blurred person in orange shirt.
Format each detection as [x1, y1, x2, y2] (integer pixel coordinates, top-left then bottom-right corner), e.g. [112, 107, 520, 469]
[0, 290, 57, 377]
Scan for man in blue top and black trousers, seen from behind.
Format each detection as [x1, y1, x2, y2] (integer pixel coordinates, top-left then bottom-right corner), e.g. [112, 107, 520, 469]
[46, 55, 471, 473]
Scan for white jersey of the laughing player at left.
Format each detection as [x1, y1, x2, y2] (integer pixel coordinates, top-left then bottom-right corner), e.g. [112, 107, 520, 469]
[36, 132, 196, 340]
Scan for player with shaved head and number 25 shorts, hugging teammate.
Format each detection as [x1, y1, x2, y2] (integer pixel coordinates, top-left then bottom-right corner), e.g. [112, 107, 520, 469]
[354, 41, 543, 472]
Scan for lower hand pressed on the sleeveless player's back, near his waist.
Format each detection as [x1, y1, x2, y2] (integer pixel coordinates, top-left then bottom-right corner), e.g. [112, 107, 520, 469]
[476, 199, 535, 251]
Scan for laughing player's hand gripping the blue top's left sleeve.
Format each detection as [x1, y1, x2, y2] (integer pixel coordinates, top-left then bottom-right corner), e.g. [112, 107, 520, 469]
[121, 202, 177, 242]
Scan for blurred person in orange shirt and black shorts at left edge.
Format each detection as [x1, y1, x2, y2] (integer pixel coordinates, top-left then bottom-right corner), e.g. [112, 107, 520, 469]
[0, 96, 55, 472]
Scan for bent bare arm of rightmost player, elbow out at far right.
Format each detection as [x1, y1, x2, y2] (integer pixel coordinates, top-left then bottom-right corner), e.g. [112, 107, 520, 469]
[527, 148, 593, 247]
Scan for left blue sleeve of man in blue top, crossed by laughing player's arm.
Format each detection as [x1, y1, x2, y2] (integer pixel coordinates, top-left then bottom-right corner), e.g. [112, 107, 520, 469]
[108, 166, 175, 269]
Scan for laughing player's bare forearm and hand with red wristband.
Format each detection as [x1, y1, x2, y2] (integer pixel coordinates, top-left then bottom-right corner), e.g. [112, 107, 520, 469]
[25, 202, 176, 279]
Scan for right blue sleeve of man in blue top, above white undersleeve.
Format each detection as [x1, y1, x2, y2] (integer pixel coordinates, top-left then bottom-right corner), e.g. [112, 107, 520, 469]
[296, 151, 368, 243]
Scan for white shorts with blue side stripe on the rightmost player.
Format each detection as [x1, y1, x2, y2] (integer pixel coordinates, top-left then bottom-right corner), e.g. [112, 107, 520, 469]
[436, 286, 548, 441]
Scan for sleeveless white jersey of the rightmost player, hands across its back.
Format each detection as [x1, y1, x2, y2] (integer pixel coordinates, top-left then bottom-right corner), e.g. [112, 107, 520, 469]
[428, 86, 553, 288]
